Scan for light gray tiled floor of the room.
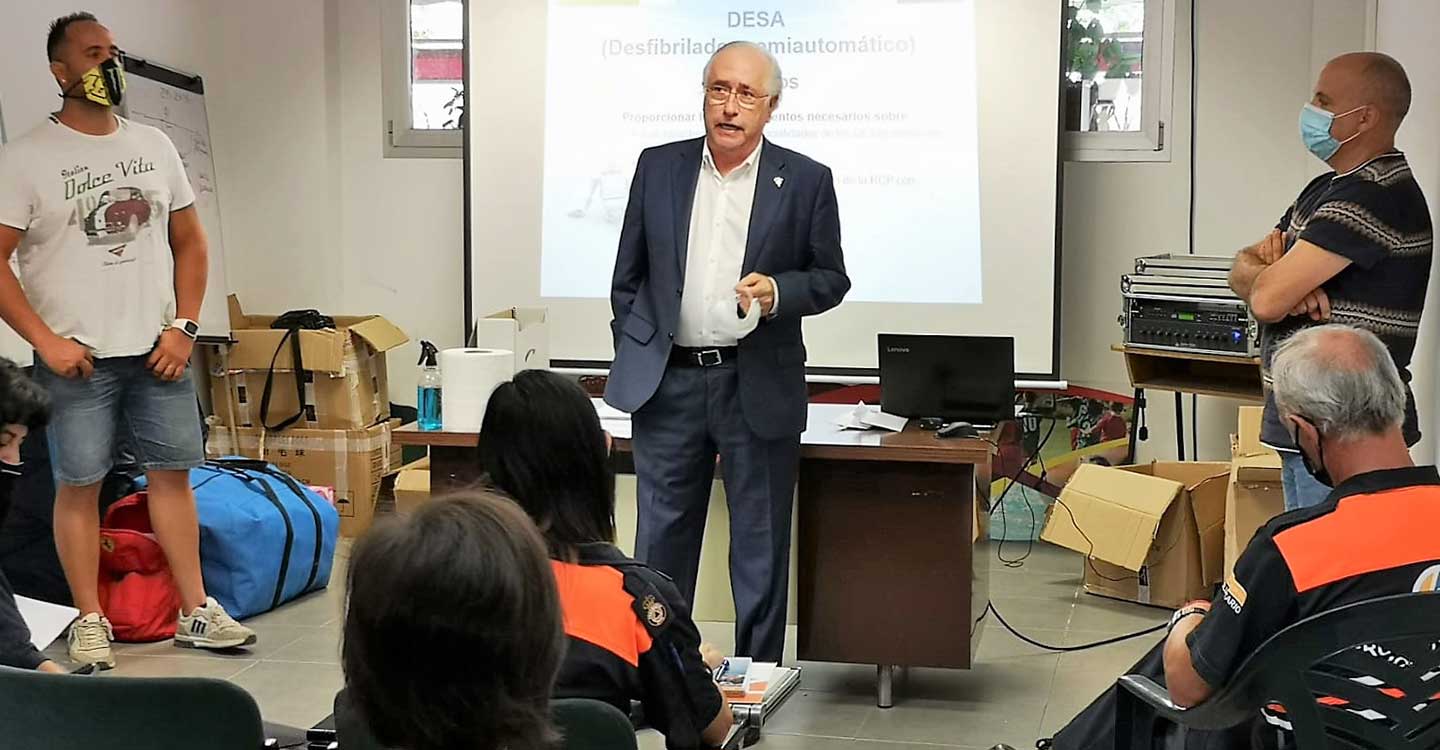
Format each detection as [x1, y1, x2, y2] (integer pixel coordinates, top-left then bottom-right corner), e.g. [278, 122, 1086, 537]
[39, 544, 1168, 750]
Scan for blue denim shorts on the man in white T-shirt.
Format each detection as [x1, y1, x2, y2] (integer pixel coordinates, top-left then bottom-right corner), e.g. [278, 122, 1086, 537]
[35, 354, 204, 487]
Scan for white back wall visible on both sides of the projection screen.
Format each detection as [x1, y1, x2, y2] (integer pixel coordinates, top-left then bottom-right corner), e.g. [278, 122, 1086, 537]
[0, 0, 1382, 434]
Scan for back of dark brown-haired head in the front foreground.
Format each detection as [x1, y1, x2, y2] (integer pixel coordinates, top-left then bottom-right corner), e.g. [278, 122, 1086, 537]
[337, 492, 564, 750]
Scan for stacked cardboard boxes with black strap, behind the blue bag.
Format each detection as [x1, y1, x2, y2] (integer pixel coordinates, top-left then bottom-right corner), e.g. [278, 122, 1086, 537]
[206, 295, 408, 537]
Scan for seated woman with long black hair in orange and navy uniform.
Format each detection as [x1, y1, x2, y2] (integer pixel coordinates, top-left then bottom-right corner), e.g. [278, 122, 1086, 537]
[480, 370, 732, 749]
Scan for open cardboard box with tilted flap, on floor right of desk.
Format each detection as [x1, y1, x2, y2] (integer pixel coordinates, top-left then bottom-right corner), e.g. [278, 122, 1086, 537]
[1040, 462, 1230, 607]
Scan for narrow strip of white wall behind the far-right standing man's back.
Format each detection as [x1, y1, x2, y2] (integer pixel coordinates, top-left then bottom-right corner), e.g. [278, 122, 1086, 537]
[1375, 0, 1440, 464]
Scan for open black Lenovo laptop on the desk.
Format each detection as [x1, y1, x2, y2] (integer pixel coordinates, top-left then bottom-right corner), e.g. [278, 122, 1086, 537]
[878, 334, 1015, 426]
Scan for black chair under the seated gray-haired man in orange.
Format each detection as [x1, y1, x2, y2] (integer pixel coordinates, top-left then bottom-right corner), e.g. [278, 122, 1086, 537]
[1115, 593, 1440, 750]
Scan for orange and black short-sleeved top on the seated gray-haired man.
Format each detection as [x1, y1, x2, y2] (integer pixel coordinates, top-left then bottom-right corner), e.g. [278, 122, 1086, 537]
[1188, 466, 1440, 726]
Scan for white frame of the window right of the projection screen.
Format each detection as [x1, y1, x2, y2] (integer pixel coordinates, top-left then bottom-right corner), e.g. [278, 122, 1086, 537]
[1060, 0, 1176, 161]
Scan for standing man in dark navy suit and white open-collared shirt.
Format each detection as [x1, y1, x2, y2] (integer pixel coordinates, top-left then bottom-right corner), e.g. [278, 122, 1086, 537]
[605, 42, 850, 661]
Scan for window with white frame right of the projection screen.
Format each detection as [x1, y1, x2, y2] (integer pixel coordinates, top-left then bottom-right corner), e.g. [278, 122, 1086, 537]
[1061, 0, 1175, 161]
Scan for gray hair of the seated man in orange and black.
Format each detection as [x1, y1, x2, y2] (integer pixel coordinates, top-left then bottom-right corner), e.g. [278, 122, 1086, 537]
[1270, 324, 1405, 440]
